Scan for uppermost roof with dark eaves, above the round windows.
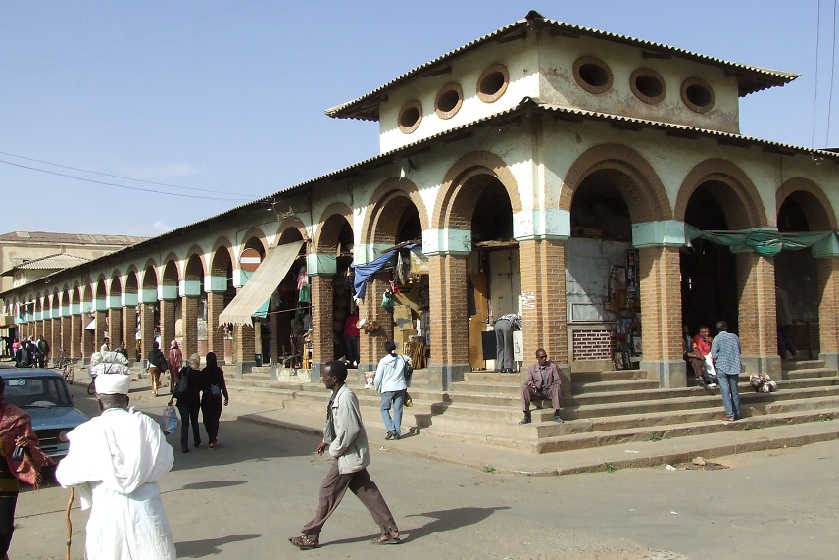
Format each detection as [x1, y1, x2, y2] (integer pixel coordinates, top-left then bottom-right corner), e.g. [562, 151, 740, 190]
[324, 11, 798, 121]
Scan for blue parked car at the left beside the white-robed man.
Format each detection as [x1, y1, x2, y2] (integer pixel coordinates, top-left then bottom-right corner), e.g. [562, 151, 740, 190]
[0, 369, 88, 461]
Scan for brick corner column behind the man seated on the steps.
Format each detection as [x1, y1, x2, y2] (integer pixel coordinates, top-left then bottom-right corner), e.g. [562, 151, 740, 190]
[519, 239, 570, 372]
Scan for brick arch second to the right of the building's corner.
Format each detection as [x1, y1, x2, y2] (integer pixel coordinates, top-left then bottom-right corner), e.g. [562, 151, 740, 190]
[673, 159, 768, 229]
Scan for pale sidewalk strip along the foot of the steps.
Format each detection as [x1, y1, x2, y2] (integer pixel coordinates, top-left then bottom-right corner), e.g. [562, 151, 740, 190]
[116, 376, 839, 476]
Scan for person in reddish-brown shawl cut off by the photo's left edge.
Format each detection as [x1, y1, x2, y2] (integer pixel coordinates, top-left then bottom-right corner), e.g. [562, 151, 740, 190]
[0, 377, 53, 560]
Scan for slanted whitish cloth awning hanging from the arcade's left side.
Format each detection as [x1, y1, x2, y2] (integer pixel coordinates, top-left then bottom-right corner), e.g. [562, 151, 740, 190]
[219, 241, 304, 325]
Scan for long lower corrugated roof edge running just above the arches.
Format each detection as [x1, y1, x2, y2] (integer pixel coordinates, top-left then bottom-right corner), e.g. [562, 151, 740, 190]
[0, 97, 839, 297]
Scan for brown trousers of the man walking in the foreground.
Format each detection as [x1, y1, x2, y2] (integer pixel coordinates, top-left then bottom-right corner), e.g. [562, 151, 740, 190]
[303, 460, 399, 535]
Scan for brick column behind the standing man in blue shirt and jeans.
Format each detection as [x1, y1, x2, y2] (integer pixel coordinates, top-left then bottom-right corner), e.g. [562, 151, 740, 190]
[736, 252, 782, 380]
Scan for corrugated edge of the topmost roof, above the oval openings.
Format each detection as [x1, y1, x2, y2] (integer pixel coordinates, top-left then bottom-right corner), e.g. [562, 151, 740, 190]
[324, 11, 798, 121]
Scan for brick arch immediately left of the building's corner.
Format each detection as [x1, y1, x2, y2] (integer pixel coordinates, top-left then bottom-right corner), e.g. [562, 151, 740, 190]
[436, 151, 522, 229]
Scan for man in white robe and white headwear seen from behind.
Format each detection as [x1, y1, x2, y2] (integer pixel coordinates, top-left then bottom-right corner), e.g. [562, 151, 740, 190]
[56, 374, 176, 560]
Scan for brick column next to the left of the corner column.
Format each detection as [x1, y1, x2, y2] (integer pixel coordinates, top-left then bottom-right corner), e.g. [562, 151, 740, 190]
[428, 252, 470, 389]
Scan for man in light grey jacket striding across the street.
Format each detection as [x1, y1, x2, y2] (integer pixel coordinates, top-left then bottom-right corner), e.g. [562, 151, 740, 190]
[288, 360, 399, 550]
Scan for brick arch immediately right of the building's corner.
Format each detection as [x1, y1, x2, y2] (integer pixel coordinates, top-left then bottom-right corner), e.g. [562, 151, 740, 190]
[559, 144, 673, 223]
